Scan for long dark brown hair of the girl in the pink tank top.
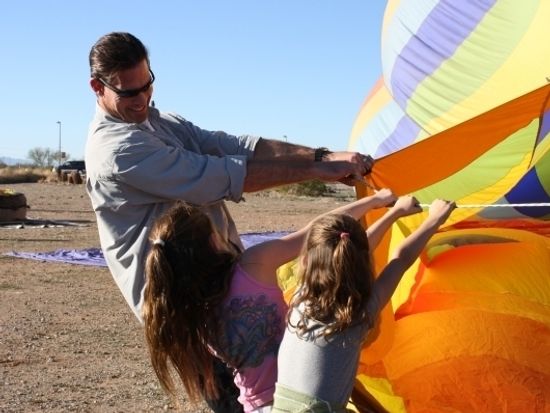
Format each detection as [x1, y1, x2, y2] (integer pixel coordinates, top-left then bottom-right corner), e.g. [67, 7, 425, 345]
[143, 202, 237, 401]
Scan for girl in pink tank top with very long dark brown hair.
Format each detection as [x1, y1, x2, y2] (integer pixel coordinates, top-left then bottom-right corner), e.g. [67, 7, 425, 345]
[143, 189, 418, 412]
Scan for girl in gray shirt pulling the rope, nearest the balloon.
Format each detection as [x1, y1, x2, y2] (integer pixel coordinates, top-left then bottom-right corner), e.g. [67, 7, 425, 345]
[272, 198, 455, 413]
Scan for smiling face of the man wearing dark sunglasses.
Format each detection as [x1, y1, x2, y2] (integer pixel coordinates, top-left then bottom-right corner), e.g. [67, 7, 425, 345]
[90, 60, 153, 123]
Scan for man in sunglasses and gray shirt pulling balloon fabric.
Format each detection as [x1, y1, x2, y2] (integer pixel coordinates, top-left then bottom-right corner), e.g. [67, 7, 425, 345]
[86, 32, 373, 412]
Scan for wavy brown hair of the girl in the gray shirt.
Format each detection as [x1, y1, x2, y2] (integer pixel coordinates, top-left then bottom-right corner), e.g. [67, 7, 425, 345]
[291, 214, 374, 338]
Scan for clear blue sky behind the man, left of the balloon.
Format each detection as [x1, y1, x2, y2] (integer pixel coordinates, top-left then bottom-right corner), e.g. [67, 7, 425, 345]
[0, 0, 386, 159]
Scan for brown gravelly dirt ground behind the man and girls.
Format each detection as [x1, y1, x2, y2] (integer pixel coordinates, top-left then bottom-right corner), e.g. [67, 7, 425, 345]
[0, 183, 354, 413]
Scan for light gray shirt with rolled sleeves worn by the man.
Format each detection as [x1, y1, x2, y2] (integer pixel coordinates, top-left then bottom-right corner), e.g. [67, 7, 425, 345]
[85, 106, 259, 320]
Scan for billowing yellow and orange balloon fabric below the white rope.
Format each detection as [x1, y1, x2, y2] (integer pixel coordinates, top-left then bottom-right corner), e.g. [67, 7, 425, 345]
[357, 228, 550, 412]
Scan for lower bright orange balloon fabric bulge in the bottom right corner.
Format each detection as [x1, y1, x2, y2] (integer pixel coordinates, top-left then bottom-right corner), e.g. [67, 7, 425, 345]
[384, 309, 550, 412]
